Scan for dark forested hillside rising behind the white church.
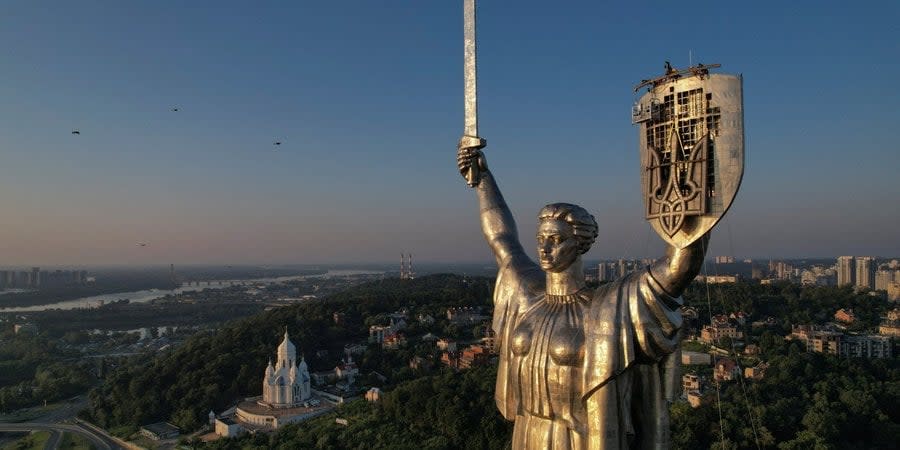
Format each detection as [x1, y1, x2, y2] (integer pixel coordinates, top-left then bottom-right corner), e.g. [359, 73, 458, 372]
[89, 275, 490, 432]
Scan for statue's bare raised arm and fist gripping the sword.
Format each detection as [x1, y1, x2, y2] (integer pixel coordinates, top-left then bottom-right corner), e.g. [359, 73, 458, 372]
[456, 136, 527, 269]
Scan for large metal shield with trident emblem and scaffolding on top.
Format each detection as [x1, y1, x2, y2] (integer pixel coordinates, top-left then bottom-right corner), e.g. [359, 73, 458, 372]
[632, 66, 744, 248]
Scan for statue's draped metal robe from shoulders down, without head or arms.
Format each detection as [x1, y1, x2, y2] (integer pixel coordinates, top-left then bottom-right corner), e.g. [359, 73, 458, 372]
[493, 266, 681, 449]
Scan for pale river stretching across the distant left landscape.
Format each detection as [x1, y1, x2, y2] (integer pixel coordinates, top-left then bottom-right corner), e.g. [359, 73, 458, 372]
[0, 270, 384, 313]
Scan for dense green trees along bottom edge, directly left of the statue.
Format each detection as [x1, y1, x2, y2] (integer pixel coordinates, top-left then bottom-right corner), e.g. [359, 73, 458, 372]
[207, 367, 512, 450]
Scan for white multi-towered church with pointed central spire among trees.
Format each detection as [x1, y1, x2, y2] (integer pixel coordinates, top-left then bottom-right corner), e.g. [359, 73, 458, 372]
[262, 330, 312, 408]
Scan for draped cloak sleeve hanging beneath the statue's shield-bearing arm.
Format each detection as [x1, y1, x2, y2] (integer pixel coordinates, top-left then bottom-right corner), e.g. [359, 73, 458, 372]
[583, 270, 682, 397]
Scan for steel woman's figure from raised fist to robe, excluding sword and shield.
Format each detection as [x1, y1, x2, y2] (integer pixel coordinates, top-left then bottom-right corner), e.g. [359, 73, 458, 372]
[457, 136, 708, 450]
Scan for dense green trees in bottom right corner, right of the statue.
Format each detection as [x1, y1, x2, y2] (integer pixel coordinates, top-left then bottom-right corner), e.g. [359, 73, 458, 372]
[672, 341, 900, 449]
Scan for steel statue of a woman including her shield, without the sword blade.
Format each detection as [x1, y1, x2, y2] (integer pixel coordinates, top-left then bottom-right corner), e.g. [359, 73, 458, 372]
[457, 61, 743, 450]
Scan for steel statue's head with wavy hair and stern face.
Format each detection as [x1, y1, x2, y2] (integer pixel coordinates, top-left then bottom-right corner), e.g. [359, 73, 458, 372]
[537, 203, 597, 272]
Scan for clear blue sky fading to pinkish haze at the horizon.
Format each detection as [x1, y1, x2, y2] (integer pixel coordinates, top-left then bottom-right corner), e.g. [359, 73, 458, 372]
[0, 0, 900, 266]
